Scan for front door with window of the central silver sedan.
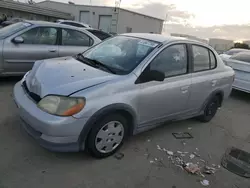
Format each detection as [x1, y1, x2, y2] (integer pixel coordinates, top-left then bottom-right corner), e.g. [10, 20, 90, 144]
[139, 44, 191, 126]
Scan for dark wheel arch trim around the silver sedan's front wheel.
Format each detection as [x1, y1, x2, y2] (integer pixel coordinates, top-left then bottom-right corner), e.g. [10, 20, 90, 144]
[78, 103, 137, 150]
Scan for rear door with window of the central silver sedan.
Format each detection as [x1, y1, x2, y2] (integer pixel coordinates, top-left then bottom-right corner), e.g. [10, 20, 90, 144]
[189, 45, 219, 113]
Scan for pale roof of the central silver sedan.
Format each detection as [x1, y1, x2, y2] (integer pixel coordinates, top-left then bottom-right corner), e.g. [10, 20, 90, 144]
[121, 33, 195, 44]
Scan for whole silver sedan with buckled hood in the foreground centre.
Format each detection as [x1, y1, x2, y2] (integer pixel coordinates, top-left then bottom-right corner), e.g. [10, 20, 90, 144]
[14, 33, 234, 157]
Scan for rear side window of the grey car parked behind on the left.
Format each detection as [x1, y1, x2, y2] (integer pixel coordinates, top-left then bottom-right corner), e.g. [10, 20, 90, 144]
[62, 29, 94, 46]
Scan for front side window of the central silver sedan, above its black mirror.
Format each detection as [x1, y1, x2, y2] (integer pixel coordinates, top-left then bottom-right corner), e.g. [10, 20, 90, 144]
[150, 44, 188, 77]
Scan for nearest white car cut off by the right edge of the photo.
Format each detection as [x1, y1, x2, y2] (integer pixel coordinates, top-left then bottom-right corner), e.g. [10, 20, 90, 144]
[224, 51, 250, 93]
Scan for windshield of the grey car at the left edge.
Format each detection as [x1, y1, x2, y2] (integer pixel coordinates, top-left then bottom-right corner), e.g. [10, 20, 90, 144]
[0, 22, 31, 39]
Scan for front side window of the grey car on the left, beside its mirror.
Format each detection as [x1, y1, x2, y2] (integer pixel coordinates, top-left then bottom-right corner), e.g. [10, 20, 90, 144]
[20, 27, 57, 45]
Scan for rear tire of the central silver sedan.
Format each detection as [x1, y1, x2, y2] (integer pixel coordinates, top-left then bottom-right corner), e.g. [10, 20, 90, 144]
[198, 96, 220, 123]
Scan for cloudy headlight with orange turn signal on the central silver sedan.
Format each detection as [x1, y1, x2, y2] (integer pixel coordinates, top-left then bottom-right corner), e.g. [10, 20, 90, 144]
[37, 95, 85, 116]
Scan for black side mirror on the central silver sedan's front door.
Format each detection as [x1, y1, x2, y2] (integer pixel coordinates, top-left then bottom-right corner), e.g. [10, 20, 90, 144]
[136, 70, 165, 83]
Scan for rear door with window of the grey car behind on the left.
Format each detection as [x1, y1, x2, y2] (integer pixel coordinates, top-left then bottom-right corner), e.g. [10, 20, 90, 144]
[59, 28, 95, 57]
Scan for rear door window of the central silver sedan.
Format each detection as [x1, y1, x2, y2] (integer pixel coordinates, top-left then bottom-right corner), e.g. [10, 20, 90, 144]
[192, 45, 216, 72]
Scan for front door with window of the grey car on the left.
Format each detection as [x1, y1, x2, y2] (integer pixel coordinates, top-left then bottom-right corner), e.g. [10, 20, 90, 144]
[3, 27, 58, 74]
